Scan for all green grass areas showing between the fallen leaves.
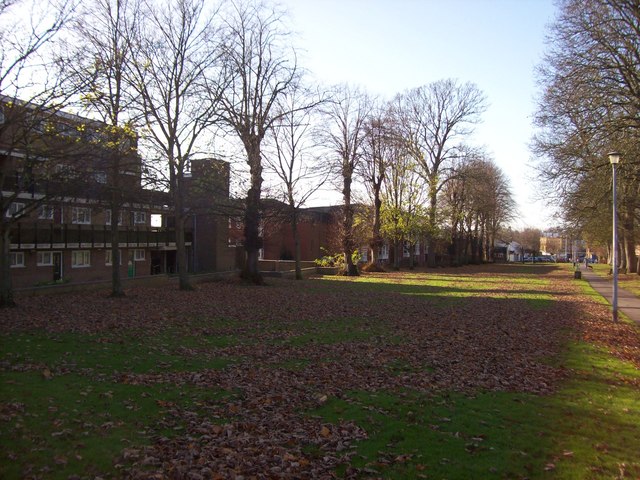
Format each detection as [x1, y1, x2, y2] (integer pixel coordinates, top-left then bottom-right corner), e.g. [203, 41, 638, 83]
[0, 265, 640, 480]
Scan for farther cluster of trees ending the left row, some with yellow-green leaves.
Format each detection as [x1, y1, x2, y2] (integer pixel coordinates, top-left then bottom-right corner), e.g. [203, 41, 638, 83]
[306, 79, 514, 274]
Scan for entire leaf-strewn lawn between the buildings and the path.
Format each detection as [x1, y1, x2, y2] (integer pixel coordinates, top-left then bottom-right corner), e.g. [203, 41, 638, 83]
[0, 265, 640, 479]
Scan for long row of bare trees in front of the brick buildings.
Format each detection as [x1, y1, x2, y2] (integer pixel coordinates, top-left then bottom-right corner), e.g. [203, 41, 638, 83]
[0, 0, 513, 306]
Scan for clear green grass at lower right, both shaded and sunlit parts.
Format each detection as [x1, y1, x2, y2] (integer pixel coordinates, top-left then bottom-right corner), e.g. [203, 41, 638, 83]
[312, 343, 640, 479]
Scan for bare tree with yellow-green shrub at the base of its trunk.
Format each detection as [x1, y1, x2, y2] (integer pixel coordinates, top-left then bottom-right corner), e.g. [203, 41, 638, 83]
[324, 85, 371, 276]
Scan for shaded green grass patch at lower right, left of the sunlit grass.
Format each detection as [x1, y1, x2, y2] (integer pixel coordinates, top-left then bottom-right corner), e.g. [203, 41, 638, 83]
[314, 392, 550, 479]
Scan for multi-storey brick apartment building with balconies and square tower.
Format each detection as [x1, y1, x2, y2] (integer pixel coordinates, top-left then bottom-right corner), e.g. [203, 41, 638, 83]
[0, 97, 235, 288]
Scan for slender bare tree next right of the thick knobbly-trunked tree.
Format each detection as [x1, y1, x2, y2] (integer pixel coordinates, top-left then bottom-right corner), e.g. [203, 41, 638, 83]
[265, 88, 327, 280]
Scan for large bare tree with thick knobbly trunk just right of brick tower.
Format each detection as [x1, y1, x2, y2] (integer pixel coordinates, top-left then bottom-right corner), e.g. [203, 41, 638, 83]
[220, 1, 298, 284]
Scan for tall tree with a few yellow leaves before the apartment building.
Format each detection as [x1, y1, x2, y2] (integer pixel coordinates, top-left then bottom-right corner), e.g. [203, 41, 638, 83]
[71, 0, 140, 297]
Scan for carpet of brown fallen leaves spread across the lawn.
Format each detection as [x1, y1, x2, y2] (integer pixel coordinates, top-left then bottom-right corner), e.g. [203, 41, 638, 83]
[0, 267, 640, 478]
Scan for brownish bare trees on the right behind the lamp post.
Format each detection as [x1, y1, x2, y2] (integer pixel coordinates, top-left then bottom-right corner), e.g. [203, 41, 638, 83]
[533, 0, 640, 272]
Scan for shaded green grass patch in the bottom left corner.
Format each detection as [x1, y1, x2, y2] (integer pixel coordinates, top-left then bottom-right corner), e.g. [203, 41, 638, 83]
[0, 371, 230, 479]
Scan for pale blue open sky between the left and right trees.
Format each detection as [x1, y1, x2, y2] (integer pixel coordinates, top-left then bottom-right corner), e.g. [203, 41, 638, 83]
[280, 0, 556, 230]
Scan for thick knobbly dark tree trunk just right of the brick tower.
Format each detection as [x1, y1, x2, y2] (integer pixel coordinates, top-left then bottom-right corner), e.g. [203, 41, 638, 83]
[241, 139, 264, 285]
